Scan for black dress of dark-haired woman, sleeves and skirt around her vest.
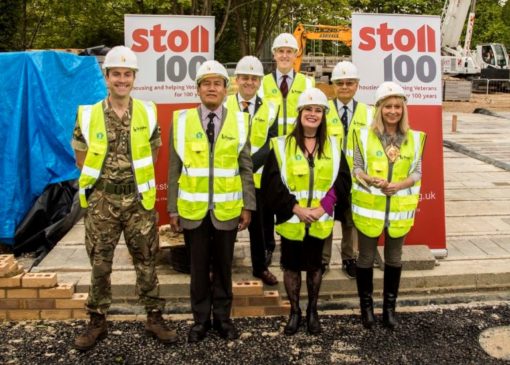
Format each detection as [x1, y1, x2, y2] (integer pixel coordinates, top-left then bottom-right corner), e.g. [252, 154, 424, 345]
[261, 146, 351, 271]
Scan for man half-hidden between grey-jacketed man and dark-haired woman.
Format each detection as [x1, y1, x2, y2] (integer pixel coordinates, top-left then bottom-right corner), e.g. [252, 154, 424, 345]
[227, 56, 278, 286]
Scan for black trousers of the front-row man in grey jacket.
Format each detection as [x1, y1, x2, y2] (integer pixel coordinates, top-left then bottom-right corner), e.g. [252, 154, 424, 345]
[184, 213, 237, 324]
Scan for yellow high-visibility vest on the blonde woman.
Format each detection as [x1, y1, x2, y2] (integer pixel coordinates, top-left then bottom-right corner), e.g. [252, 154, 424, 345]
[352, 128, 425, 238]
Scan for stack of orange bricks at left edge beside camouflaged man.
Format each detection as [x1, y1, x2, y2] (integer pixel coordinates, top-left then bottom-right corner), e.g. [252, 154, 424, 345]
[0, 255, 88, 321]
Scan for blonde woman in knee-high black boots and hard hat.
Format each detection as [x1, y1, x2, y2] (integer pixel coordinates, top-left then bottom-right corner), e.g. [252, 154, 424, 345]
[352, 82, 425, 329]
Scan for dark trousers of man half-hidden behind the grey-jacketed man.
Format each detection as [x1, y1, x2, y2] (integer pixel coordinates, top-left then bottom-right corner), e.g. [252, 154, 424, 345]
[248, 189, 274, 274]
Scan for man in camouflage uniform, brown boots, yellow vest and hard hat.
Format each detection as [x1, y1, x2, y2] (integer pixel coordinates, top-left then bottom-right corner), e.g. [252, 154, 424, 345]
[72, 46, 177, 350]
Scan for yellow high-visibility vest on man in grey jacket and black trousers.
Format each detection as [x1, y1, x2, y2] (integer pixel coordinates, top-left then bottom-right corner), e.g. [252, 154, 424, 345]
[173, 108, 249, 221]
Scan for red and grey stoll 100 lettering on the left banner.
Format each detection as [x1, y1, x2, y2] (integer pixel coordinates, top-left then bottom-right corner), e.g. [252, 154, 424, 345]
[131, 24, 210, 82]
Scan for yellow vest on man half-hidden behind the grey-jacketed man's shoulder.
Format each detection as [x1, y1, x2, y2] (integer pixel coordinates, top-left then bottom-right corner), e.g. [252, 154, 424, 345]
[225, 95, 278, 189]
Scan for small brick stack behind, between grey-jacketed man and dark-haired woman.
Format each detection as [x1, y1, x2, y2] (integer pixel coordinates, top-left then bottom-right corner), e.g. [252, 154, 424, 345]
[232, 280, 290, 317]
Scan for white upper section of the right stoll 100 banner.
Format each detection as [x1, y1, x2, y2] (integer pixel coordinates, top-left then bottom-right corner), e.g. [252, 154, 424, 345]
[352, 13, 442, 105]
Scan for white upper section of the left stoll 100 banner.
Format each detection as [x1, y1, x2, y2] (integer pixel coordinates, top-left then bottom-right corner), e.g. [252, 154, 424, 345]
[124, 15, 214, 104]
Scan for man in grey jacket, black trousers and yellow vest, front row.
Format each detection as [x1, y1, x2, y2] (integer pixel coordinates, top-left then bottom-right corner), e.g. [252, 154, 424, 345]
[168, 61, 256, 343]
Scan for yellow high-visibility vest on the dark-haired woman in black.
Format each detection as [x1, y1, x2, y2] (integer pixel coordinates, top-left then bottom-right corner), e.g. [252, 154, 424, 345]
[271, 136, 341, 241]
